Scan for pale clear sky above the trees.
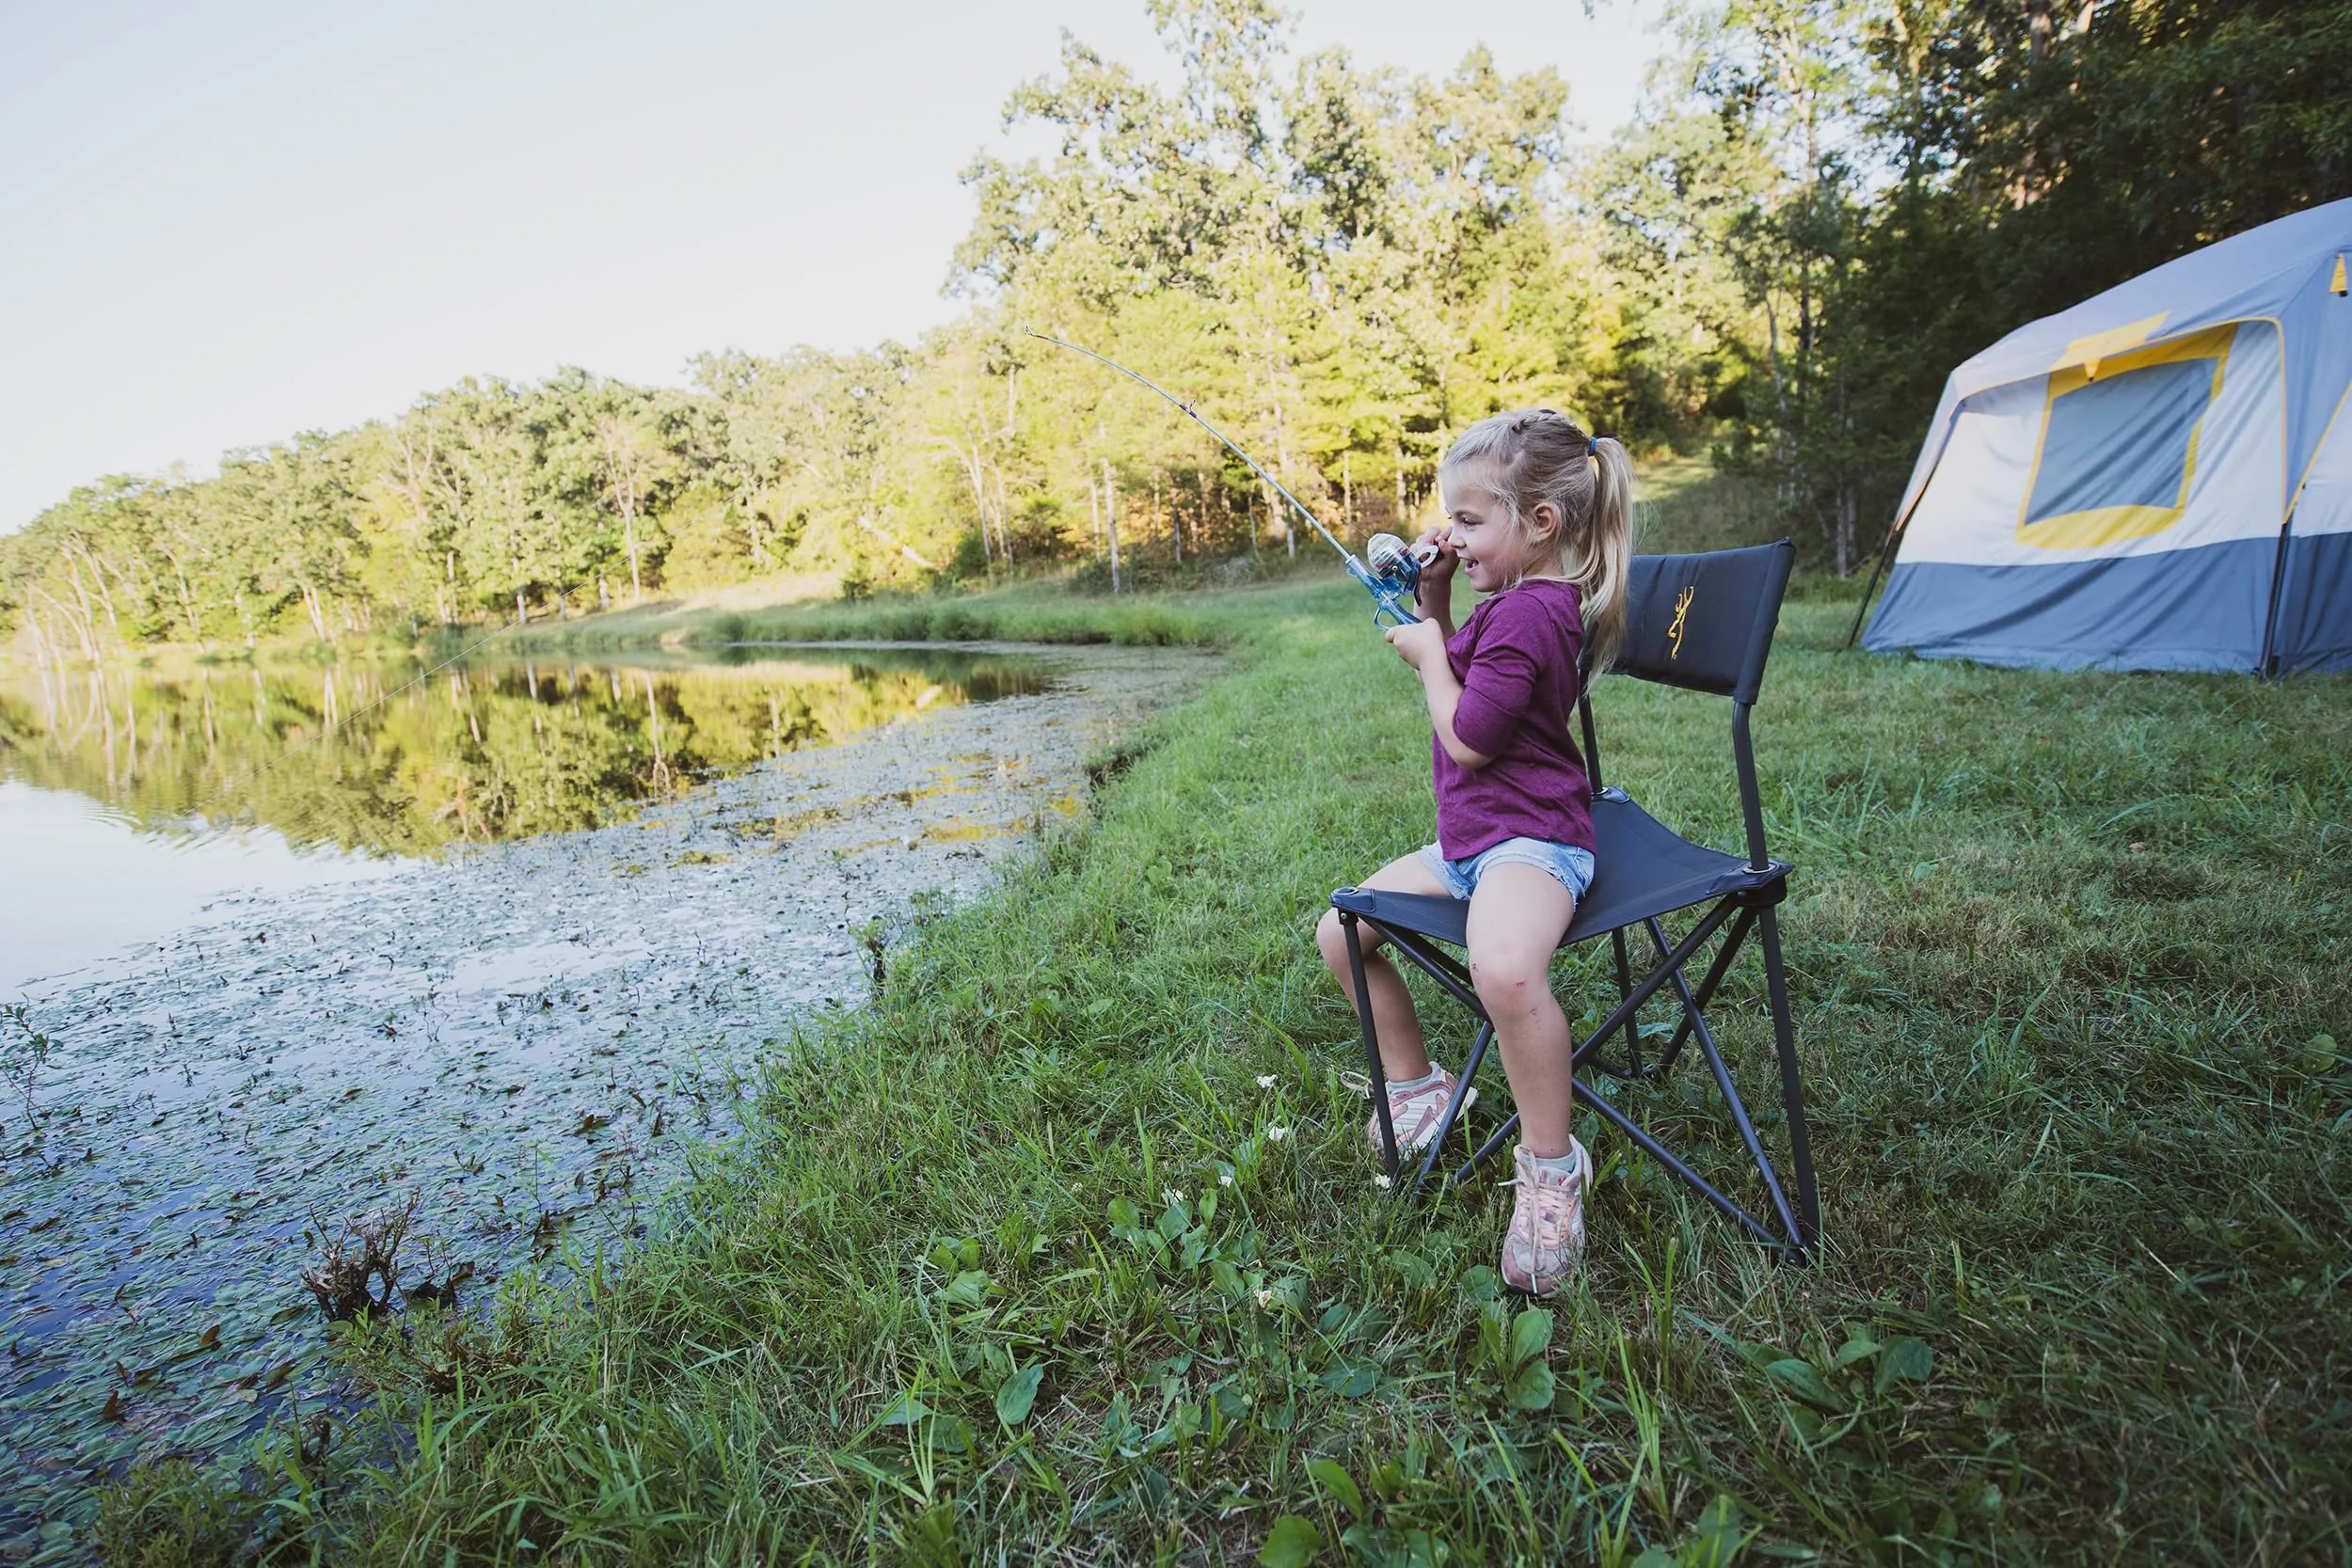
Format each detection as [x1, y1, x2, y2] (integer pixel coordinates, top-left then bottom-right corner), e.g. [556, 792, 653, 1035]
[0, 0, 1659, 533]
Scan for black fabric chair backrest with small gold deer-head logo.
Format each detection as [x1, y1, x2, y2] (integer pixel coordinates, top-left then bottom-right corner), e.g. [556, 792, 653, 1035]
[1612, 538, 1797, 703]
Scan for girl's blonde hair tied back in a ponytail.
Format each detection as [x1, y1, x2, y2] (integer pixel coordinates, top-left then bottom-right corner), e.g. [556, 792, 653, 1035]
[1438, 409, 1632, 674]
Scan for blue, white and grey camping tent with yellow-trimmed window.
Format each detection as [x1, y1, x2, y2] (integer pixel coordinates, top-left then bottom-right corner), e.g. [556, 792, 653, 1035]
[1863, 199, 2352, 670]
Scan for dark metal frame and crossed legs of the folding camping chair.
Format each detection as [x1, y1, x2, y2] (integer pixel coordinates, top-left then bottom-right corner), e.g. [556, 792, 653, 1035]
[1331, 541, 1820, 1262]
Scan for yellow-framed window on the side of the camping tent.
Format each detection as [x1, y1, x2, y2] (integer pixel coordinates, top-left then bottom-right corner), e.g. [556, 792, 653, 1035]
[2018, 326, 2233, 550]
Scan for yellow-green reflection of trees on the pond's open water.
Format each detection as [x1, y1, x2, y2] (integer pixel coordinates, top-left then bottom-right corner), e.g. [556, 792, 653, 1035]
[0, 649, 1047, 856]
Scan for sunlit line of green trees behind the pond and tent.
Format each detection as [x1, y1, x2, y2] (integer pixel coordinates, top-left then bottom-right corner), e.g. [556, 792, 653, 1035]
[0, 0, 2352, 660]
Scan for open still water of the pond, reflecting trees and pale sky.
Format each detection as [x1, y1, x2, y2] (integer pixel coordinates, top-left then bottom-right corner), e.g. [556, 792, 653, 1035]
[0, 649, 1049, 999]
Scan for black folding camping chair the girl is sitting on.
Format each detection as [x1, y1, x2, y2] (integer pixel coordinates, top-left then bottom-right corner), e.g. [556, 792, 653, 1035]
[1331, 538, 1820, 1258]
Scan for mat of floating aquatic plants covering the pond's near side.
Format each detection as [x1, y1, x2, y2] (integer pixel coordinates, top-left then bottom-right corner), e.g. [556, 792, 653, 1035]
[0, 651, 1193, 1540]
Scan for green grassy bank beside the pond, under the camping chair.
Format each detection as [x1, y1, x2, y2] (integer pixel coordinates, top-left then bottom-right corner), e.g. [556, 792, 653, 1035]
[216, 583, 2352, 1566]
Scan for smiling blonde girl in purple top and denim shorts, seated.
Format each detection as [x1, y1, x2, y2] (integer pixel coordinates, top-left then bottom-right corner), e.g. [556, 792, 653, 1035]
[1315, 409, 1632, 1295]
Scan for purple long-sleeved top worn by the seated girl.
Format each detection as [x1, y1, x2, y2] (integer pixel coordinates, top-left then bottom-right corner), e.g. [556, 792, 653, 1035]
[1430, 580, 1593, 861]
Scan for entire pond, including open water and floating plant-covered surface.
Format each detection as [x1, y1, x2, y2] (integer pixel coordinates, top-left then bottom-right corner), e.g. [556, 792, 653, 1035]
[0, 644, 1207, 1552]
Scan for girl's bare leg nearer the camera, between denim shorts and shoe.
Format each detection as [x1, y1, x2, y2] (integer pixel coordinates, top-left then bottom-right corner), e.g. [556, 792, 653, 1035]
[1468, 865, 1576, 1159]
